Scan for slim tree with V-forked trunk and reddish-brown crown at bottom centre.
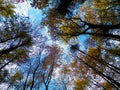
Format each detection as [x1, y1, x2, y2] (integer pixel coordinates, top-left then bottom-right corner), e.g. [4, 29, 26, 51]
[41, 46, 59, 90]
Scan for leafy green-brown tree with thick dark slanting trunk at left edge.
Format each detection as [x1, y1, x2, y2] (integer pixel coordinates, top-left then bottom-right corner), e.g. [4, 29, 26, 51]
[0, 16, 32, 82]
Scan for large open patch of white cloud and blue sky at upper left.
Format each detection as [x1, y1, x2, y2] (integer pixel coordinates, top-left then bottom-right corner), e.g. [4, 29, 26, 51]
[15, 2, 42, 26]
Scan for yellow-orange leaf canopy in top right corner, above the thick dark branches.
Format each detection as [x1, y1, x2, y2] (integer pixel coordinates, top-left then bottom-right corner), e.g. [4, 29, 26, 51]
[79, 0, 120, 24]
